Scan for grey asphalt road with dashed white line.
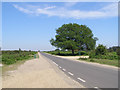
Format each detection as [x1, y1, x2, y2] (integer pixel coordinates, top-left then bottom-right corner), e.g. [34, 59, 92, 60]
[41, 53, 118, 88]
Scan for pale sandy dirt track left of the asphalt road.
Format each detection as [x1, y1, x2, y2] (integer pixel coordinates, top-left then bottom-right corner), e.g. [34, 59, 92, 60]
[2, 54, 83, 88]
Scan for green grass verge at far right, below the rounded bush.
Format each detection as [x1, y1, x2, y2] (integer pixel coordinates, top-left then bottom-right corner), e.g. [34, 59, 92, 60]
[79, 52, 119, 67]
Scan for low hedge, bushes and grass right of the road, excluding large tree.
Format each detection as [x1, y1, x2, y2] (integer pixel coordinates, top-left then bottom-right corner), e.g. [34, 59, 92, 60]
[45, 45, 120, 67]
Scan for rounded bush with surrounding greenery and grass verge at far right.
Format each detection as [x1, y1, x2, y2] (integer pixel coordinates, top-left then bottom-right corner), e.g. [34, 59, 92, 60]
[79, 45, 120, 67]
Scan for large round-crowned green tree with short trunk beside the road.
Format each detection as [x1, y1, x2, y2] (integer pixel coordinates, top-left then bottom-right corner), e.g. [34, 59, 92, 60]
[50, 23, 98, 54]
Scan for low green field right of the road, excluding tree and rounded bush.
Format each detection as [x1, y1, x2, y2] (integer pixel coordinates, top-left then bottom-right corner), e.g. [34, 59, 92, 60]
[46, 51, 119, 67]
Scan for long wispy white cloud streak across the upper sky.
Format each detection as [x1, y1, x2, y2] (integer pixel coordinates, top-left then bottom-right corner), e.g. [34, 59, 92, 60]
[14, 3, 118, 19]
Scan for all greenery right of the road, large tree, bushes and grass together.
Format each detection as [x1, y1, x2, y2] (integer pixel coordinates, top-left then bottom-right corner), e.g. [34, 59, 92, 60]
[46, 23, 120, 66]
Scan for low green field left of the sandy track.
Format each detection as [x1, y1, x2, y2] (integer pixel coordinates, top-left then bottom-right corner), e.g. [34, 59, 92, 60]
[2, 50, 37, 65]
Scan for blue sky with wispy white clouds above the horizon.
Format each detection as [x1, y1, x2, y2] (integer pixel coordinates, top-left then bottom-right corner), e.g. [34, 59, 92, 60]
[2, 2, 118, 51]
